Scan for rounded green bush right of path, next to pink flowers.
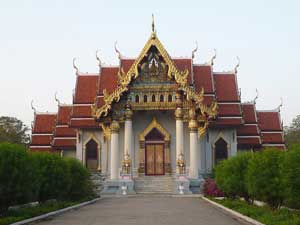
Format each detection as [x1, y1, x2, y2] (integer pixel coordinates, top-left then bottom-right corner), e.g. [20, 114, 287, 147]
[215, 152, 253, 202]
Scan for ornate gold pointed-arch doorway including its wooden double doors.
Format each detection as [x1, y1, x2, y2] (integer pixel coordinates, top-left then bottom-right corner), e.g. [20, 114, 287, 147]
[139, 118, 171, 175]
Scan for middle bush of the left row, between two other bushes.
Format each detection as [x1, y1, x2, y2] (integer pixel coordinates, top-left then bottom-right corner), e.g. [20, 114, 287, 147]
[32, 153, 71, 202]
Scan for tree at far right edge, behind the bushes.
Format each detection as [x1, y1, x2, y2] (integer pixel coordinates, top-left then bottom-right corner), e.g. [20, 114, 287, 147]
[284, 115, 300, 146]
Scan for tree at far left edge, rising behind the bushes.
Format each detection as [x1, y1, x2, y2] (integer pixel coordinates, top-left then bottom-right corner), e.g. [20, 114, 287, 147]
[0, 116, 30, 145]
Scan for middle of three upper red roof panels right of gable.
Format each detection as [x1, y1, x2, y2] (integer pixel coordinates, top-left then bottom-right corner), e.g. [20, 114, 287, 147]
[193, 65, 214, 93]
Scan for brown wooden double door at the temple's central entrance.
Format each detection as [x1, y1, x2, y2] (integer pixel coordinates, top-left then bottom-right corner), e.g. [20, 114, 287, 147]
[145, 143, 165, 176]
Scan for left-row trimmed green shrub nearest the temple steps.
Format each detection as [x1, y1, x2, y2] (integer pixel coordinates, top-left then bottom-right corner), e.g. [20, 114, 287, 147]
[65, 158, 95, 200]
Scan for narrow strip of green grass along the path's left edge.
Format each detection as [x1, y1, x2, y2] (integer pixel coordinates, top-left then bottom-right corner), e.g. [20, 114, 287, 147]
[0, 199, 91, 225]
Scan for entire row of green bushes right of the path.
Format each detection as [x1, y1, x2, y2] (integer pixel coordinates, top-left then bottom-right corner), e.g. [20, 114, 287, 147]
[215, 145, 300, 209]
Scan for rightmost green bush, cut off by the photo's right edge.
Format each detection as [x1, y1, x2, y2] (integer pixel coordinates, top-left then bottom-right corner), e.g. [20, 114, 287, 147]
[282, 145, 300, 209]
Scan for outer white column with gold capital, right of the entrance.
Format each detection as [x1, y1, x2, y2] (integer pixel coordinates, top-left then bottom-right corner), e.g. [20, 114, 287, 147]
[189, 109, 200, 179]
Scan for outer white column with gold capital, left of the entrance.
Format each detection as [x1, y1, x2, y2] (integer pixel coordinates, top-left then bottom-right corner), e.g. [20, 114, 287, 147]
[110, 120, 120, 180]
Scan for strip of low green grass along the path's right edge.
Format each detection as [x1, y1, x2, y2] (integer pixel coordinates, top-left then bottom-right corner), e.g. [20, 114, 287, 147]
[210, 198, 300, 225]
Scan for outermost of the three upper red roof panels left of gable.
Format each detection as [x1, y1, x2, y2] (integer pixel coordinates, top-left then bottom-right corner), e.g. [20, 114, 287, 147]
[74, 75, 99, 104]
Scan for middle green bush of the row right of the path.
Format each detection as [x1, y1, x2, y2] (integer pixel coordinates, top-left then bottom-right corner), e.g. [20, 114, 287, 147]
[246, 149, 283, 209]
